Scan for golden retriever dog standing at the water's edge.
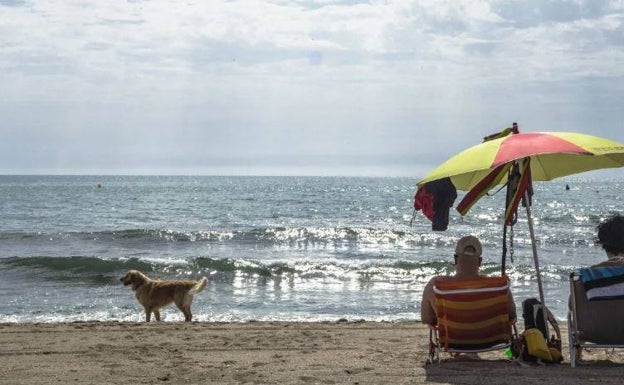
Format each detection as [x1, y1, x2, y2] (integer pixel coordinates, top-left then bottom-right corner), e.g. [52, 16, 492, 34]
[121, 270, 208, 322]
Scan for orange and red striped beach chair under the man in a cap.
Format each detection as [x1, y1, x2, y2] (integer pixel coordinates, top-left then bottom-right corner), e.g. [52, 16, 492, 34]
[429, 276, 518, 362]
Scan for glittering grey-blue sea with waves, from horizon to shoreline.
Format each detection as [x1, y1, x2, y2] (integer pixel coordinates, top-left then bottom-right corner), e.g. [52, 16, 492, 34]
[0, 174, 624, 323]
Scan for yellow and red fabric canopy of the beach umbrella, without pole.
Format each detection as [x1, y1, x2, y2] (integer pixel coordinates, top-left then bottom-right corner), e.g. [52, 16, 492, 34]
[417, 132, 624, 190]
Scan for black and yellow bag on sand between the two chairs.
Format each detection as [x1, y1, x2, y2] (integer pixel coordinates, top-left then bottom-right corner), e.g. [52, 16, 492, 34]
[521, 298, 563, 363]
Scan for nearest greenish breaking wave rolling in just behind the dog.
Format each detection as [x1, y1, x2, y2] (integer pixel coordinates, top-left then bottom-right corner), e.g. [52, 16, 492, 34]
[0, 256, 570, 284]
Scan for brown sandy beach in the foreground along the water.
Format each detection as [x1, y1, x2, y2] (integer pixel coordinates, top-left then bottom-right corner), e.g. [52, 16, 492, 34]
[0, 322, 624, 385]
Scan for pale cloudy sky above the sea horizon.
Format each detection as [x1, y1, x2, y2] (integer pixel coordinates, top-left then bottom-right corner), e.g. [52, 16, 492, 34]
[0, 0, 624, 178]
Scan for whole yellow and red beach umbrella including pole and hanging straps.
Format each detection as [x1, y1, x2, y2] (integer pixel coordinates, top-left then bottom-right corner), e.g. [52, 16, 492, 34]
[415, 123, 624, 303]
